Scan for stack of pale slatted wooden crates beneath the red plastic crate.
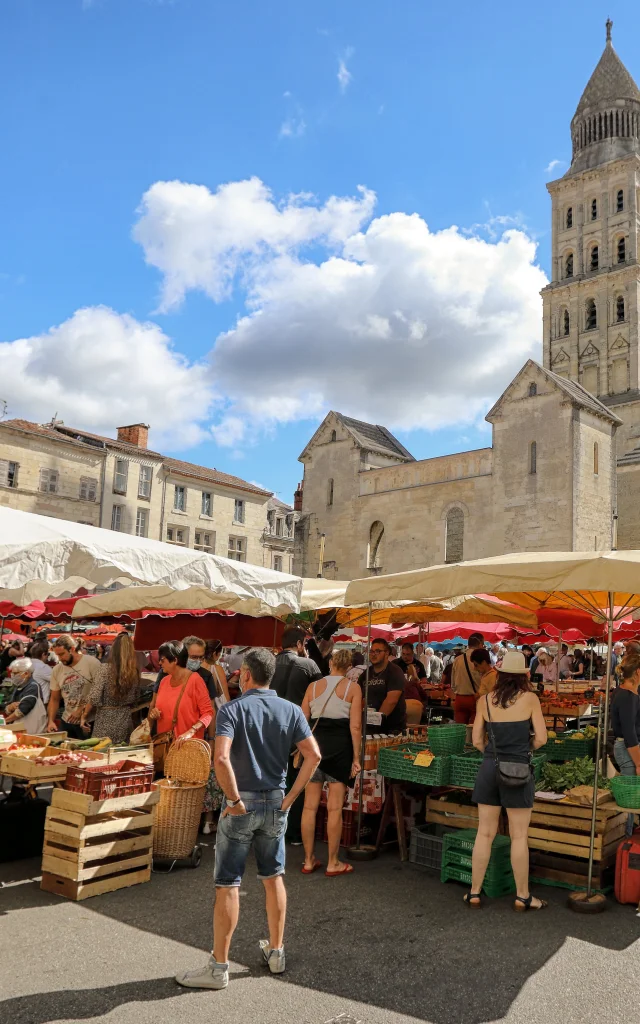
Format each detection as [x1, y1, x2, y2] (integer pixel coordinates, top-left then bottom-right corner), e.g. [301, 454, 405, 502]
[41, 787, 160, 900]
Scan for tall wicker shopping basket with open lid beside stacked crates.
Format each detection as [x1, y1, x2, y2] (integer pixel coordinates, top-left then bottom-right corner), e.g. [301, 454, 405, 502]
[154, 739, 211, 860]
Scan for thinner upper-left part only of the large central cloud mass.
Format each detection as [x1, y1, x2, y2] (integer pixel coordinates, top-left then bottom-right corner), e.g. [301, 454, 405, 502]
[133, 177, 375, 310]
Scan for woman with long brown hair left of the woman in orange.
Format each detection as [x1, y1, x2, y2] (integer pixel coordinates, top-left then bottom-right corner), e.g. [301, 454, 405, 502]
[80, 633, 141, 743]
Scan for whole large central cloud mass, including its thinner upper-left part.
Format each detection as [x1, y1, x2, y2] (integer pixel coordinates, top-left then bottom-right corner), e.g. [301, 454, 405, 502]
[136, 179, 546, 450]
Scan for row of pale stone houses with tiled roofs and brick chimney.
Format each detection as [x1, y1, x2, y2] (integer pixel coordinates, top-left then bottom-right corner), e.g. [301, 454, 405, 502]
[0, 420, 278, 571]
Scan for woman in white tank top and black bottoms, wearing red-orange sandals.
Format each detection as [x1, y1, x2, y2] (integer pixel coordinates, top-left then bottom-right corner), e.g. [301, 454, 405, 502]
[301, 649, 362, 879]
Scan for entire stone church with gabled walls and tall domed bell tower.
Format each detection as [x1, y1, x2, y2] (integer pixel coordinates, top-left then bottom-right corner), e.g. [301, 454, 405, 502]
[294, 23, 640, 580]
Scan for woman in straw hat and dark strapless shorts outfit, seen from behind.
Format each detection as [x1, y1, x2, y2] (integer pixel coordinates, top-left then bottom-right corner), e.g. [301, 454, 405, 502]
[465, 650, 547, 910]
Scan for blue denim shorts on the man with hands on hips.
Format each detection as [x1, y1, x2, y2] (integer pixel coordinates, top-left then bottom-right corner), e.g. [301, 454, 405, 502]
[214, 790, 288, 889]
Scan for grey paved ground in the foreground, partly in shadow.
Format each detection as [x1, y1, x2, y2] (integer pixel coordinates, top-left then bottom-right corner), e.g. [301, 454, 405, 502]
[0, 846, 640, 1024]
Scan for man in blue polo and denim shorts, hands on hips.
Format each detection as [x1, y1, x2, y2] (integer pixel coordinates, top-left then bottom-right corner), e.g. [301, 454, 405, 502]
[176, 647, 321, 988]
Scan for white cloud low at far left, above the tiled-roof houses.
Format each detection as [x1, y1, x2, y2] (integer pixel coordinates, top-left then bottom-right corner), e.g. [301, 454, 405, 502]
[0, 306, 214, 450]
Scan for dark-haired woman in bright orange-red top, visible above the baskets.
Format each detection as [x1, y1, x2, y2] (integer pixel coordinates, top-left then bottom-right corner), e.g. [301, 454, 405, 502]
[148, 641, 213, 742]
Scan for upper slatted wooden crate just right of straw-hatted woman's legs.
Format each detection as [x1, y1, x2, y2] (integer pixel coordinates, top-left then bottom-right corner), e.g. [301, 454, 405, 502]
[528, 800, 627, 861]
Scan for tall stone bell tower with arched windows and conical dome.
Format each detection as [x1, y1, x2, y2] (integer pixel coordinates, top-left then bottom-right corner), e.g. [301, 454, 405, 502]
[542, 20, 640, 455]
